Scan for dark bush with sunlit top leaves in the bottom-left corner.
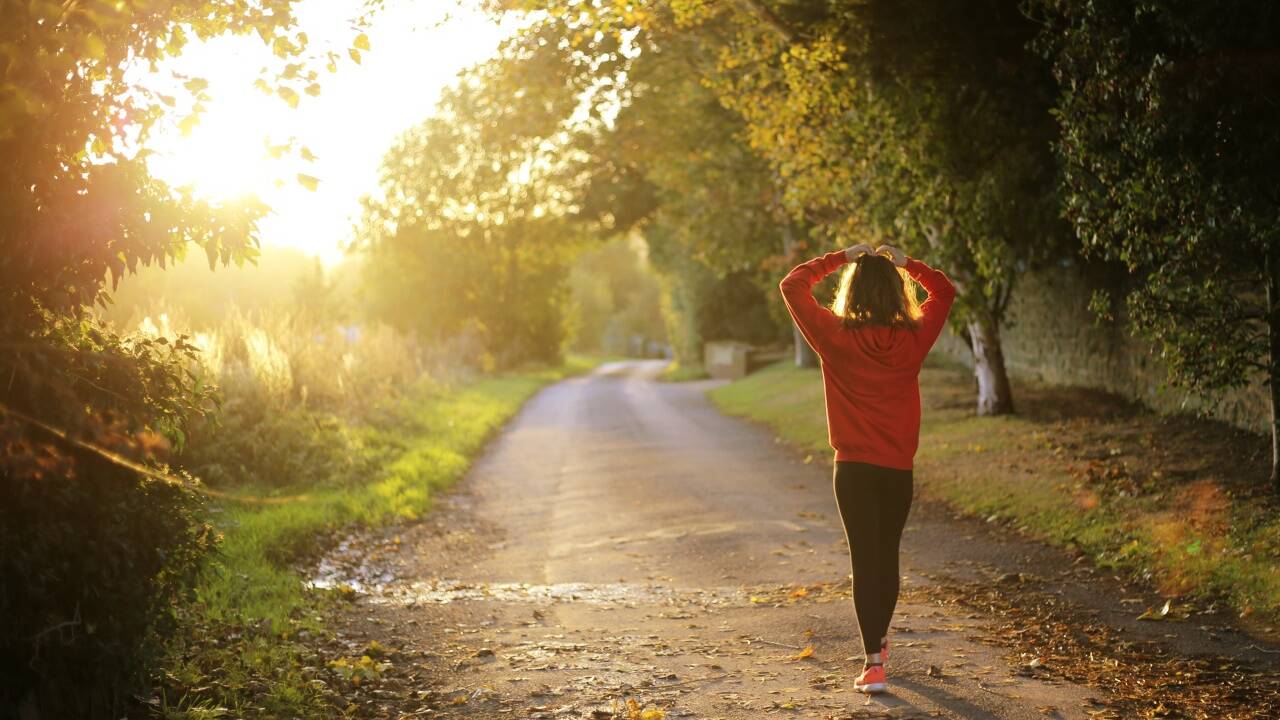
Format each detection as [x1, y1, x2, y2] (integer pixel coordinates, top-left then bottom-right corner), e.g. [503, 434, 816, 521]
[0, 302, 220, 719]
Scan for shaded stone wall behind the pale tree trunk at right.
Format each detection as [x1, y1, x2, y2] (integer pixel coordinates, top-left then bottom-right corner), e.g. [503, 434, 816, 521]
[937, 263, 1271, 433]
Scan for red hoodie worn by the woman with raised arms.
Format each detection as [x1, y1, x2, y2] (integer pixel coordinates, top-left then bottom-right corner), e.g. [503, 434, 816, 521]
[780, 250, 956, 470]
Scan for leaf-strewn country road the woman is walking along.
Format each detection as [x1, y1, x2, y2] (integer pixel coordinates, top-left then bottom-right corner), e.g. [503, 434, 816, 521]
[320, 361, 1280, 719]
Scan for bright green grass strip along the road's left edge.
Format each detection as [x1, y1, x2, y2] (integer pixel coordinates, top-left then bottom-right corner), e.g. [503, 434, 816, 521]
[161, 356, 599, 717]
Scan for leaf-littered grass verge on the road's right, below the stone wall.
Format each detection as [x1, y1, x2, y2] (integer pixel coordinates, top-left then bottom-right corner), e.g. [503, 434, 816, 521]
[709, 361, 1280, 634]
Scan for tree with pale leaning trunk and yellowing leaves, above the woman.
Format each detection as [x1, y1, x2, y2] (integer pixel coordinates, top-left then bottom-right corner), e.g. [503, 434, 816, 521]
[677, 0, 1065, 414]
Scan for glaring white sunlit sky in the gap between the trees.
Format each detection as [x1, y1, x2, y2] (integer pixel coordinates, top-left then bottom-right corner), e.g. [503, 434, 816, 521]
[138, 0, 512, 266]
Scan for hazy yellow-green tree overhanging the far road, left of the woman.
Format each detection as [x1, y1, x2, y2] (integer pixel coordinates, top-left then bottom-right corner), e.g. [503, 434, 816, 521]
[489, 0, 817, 365]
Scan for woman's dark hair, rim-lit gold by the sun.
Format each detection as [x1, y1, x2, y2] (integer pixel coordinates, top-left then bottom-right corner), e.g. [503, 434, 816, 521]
[831, 255, 920, 329]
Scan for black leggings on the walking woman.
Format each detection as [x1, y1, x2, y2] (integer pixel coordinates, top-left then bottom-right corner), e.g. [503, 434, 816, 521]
[835, 462, 913, 653]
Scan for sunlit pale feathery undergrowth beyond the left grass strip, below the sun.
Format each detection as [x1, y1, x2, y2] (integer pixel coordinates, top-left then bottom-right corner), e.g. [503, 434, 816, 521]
[138, 309, 432, 489]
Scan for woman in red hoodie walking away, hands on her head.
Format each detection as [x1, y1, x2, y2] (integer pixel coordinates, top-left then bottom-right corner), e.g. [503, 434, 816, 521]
[781, 245, 956, 693]
